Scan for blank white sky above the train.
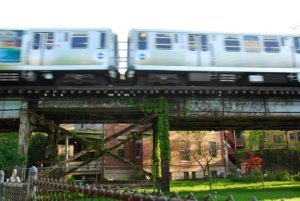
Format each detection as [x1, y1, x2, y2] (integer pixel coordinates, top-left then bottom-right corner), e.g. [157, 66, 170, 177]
[0, 0, 300, 41]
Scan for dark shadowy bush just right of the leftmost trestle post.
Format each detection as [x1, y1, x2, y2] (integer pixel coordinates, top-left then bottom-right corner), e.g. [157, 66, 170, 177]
[28, 133, 49, 167]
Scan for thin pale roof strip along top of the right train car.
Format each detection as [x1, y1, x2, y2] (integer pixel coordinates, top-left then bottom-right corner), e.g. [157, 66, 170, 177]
[129, 29, 300, 36]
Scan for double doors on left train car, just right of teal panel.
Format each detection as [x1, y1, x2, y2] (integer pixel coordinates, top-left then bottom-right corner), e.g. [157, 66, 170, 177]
[29, 32, 54, 66]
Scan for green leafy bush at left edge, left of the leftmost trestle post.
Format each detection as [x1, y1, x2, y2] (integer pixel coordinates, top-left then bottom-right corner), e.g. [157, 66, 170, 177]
[0, 137, 26, 172]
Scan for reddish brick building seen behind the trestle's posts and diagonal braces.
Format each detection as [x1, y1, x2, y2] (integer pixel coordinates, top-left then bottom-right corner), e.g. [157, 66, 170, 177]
[60, 124, 244, 180]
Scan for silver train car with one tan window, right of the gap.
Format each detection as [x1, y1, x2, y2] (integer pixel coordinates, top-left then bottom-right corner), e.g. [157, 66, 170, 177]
[126, 29, 300, 85]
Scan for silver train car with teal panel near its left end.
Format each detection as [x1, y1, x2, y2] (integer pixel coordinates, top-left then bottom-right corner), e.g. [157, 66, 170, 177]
[0, 29, 118, 85]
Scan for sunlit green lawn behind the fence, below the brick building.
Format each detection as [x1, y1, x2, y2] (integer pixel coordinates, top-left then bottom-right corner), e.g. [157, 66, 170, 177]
[171, 180, 300, 201]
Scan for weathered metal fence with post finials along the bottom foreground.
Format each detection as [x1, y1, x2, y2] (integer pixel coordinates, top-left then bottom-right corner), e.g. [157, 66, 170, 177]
[0, 166, 286, 201]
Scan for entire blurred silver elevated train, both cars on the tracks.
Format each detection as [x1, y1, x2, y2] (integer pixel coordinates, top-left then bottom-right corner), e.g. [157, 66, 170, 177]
[0, 29, 300, 86]
